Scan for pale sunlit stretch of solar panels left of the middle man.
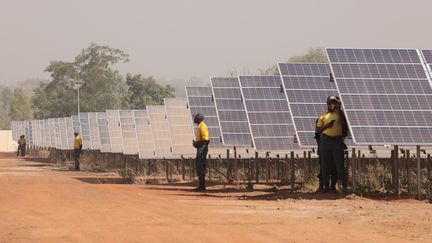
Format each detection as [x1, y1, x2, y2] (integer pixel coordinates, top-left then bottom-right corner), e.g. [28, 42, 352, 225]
[11, 98, 195, 158]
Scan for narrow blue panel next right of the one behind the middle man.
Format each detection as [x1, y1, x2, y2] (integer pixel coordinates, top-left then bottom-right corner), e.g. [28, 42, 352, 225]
[210, 77, 252, 146]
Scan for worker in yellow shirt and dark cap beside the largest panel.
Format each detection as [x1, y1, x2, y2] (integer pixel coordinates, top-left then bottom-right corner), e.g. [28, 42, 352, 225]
[315, 96, 348, 192]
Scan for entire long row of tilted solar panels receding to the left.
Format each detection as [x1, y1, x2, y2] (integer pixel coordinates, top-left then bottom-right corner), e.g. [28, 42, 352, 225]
[11, 45, 432, 159]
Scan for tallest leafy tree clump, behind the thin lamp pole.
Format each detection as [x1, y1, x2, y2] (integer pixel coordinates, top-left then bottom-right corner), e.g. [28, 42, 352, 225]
[32, 44, 128, 119]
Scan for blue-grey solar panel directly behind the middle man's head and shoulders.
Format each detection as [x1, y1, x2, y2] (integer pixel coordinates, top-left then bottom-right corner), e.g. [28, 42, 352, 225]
[186, 86, 223, 148]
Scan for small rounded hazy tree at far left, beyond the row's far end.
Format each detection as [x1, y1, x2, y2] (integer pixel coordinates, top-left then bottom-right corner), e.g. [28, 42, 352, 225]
[9, 88, 33, 121]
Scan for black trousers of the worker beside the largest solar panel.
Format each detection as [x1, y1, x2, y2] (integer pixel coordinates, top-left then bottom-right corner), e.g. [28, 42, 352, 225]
[320, 135, 347, 188]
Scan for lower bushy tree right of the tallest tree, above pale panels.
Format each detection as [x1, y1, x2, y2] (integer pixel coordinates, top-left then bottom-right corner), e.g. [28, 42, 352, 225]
[126, 74, 175, 109]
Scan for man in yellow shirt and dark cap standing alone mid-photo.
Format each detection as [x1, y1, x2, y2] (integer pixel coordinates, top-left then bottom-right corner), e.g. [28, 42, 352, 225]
[193, 113, 209, 191]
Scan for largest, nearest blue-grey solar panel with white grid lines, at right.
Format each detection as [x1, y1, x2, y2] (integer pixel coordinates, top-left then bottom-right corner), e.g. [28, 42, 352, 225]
[326, 48, 432, 145]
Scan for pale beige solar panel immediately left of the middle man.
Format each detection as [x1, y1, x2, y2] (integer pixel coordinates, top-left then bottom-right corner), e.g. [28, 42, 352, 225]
[164, 98, 196, 155]
